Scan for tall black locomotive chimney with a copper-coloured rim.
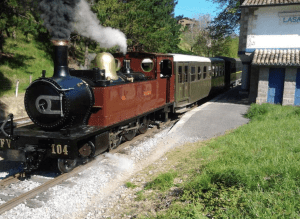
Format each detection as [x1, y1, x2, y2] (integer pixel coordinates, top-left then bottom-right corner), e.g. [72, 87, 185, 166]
[52, 40, 70, 78]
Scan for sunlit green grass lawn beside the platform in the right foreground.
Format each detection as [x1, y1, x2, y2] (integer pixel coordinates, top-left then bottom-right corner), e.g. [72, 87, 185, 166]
[152, 104, 300, 218]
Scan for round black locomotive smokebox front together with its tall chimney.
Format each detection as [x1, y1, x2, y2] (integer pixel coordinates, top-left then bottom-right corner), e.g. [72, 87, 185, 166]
[24, 40, 94, 130]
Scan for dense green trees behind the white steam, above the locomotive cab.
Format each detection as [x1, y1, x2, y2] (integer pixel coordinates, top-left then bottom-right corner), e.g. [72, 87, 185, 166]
[92, 0, 180, 53]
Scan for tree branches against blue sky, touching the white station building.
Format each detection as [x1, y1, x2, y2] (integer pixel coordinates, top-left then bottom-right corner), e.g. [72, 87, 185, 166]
[209, 0, 241, 38]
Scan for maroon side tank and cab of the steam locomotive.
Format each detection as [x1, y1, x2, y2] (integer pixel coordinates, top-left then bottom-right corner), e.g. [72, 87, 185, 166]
[88, 53, 175, 127]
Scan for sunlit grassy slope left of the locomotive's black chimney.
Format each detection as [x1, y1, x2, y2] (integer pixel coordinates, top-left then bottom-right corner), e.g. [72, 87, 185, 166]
[0, 33, 53, 96]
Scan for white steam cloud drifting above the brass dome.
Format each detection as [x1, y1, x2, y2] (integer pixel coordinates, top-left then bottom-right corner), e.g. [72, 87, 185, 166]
[73, 0, 127, 54]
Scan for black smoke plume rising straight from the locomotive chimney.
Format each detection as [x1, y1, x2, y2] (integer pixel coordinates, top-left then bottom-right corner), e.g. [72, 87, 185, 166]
[39, 0, 80, 40]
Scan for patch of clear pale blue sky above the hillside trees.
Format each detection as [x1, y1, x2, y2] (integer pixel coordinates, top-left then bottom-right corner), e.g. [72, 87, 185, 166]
[175, 0, 220, 18]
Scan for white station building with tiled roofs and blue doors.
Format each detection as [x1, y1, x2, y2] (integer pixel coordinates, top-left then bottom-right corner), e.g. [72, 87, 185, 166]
[239, 0, 300, 105]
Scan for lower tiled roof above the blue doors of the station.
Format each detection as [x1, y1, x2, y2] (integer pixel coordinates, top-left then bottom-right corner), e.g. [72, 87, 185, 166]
[252, 49, 300, 66]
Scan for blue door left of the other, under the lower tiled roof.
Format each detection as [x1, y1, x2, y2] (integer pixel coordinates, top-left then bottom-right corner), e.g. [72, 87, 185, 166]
[267, 68, 285, 104]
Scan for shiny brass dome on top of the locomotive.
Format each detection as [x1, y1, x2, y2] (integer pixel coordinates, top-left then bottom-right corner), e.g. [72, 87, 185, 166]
[93, 52, 118, 80]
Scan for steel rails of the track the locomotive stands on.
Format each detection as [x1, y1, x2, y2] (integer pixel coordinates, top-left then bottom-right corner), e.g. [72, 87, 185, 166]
[0, 116, 180, 215]
